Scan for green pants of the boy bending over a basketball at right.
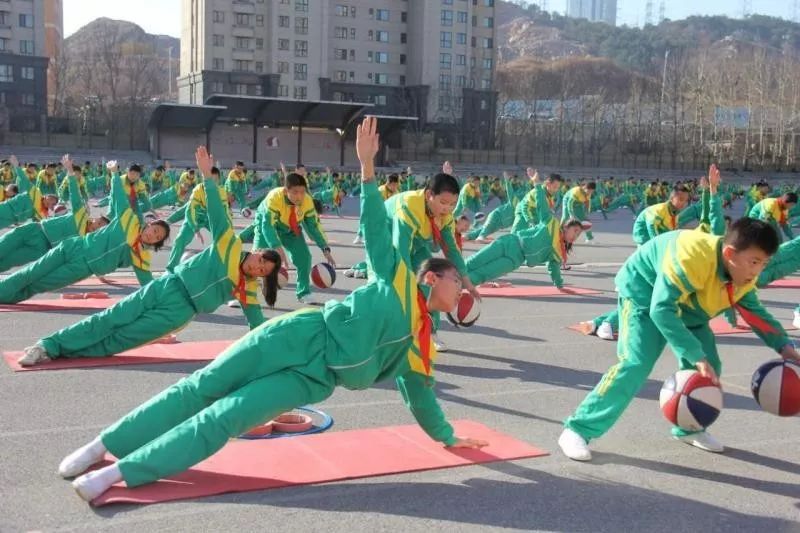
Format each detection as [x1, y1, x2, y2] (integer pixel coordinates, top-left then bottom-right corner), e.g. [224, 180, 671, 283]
[564, 298, 722, 441]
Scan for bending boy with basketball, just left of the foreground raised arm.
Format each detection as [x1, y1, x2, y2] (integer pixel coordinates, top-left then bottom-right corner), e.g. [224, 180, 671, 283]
[253, 172, 336, 304]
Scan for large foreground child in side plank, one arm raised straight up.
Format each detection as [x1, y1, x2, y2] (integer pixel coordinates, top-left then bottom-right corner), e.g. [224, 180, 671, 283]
[59, 117, 488, 501]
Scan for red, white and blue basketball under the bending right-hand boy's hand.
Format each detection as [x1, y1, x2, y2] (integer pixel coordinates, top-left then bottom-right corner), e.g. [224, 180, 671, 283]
[659, 370, 722, 431]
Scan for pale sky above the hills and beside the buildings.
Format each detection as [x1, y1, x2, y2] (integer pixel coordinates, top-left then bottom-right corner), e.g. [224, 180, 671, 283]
[64, 0, 800, 37]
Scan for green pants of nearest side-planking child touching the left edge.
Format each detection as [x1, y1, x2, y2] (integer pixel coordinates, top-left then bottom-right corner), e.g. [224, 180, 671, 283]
[0, 239, 92, 304]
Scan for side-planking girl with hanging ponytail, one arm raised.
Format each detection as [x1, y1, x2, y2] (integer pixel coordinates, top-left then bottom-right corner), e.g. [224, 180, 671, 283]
[19, 147, 280, 366]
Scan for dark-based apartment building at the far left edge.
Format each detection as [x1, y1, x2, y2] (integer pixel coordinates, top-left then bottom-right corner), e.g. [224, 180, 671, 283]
[0, 0, 63, 131]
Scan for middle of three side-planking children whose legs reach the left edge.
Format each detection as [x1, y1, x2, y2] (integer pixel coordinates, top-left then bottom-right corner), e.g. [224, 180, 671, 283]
[0, 157, 108, 272]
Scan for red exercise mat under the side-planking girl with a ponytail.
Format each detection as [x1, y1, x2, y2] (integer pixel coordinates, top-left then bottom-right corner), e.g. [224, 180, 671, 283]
[3, 337, 234, 372]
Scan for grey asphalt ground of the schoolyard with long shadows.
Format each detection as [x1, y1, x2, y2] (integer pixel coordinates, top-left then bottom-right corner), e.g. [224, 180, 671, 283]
[0, 199, 800, 533]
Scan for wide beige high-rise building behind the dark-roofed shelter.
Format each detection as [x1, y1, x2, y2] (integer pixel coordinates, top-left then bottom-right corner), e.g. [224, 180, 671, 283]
[178, 0, 496, 145]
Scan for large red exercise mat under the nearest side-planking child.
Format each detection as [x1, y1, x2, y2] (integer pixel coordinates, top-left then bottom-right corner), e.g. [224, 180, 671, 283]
[92, 420, 547, 506]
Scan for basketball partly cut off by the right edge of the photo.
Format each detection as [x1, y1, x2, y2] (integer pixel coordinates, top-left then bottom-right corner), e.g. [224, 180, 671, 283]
[750, 359, 800, 416]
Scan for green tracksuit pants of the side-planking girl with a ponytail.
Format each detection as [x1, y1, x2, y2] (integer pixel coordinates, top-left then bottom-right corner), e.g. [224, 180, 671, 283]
[39, 275, 196, 358]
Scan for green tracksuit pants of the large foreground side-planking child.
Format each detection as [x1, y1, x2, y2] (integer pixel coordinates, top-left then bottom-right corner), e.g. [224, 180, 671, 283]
[101, 309, 336, 487]
